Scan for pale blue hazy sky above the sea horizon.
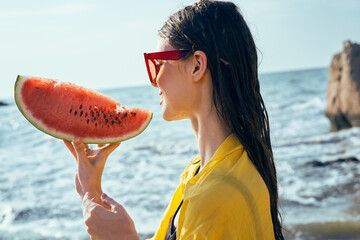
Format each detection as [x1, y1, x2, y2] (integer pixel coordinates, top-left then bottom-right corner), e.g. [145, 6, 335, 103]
[0, 0, 360, 100]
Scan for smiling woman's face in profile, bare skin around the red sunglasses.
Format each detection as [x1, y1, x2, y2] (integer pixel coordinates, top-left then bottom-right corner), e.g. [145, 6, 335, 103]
[156, 38, 197, 121]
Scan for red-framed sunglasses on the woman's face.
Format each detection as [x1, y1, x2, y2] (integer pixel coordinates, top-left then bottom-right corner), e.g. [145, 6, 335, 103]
[144, 50, 191, 87]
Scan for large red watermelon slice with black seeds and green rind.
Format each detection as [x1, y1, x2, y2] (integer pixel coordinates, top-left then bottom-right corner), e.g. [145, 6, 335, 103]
[15, 75, 152, 143]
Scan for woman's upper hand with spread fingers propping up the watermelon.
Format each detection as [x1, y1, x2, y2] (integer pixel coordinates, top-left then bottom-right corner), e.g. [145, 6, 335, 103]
[64, 138, 120, 199]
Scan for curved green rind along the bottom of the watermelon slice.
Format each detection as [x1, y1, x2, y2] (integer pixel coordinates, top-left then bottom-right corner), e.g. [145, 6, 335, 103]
[14, 75, 153, 144]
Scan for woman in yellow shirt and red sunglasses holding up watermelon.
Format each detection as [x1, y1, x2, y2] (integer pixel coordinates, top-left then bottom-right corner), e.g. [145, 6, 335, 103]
[65, 0, 283, 240]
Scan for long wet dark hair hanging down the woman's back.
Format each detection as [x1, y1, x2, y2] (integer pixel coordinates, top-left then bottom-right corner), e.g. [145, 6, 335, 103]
[159, 0, 284, 239]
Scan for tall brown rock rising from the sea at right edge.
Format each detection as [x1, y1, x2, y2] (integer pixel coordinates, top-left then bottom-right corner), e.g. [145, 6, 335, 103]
[325, 41, 360, 131]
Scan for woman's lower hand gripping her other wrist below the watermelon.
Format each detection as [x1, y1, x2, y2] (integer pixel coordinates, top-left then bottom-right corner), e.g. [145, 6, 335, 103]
[83, 192, 139, 240]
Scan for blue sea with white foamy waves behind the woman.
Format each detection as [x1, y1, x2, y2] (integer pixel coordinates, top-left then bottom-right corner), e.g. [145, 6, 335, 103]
[0, 68, 360, 240]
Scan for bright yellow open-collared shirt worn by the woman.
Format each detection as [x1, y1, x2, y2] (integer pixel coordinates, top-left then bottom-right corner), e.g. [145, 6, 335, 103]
[148, 134, 274, 240]
